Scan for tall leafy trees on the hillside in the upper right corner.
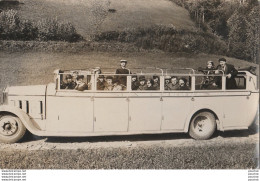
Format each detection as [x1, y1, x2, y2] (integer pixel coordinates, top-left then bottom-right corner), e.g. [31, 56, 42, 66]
[172, 0, 260, 63]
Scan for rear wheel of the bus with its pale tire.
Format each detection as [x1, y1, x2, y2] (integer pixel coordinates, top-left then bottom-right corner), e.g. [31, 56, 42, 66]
[189, 112, 217, 140]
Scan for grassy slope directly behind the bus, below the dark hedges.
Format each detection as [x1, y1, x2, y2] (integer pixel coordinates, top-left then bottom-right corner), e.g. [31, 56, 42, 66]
[0, 52, 254, 89]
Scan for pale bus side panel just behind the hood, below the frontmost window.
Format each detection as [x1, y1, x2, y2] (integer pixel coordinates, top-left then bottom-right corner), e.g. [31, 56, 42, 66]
[46, 95, 94, 132]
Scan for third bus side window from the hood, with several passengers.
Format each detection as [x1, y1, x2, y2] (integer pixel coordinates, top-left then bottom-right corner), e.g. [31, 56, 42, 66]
[131, 75, 160, 91]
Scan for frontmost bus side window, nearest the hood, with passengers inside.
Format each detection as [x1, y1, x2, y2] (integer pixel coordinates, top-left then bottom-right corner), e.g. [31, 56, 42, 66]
[60, 72, 92, 91]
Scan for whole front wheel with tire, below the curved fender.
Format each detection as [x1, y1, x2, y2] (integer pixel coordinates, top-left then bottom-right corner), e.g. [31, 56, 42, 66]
[0, 115, 26, 143]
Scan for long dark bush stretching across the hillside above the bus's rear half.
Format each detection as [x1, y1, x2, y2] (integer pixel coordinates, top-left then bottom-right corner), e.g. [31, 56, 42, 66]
[94, 25, 227, 54]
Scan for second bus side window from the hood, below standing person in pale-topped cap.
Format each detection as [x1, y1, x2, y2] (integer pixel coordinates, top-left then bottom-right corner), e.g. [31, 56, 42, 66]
[96, 75, 127, 91]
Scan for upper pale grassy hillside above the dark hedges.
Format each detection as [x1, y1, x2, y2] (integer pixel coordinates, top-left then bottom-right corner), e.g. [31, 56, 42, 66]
[17, 0, 195, 38]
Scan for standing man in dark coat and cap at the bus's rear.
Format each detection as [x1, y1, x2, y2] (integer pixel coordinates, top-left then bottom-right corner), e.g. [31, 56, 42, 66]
[217, 58, 237, 89]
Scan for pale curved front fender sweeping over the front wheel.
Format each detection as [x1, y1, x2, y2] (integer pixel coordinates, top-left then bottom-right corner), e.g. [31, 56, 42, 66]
[0, 105, 40, 135]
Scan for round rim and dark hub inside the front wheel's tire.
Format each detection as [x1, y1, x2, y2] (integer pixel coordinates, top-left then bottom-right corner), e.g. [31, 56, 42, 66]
[0, 117, 18, 136]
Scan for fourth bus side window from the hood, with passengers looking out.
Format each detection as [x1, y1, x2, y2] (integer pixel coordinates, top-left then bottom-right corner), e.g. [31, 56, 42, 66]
[164, 76, 191, 90]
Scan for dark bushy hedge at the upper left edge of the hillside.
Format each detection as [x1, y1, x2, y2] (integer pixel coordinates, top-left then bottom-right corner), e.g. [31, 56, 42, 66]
[0, 10, 81, 42]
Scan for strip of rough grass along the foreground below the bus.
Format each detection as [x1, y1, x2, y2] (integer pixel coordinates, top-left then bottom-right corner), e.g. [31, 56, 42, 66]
[0, 143, 257, 169]
